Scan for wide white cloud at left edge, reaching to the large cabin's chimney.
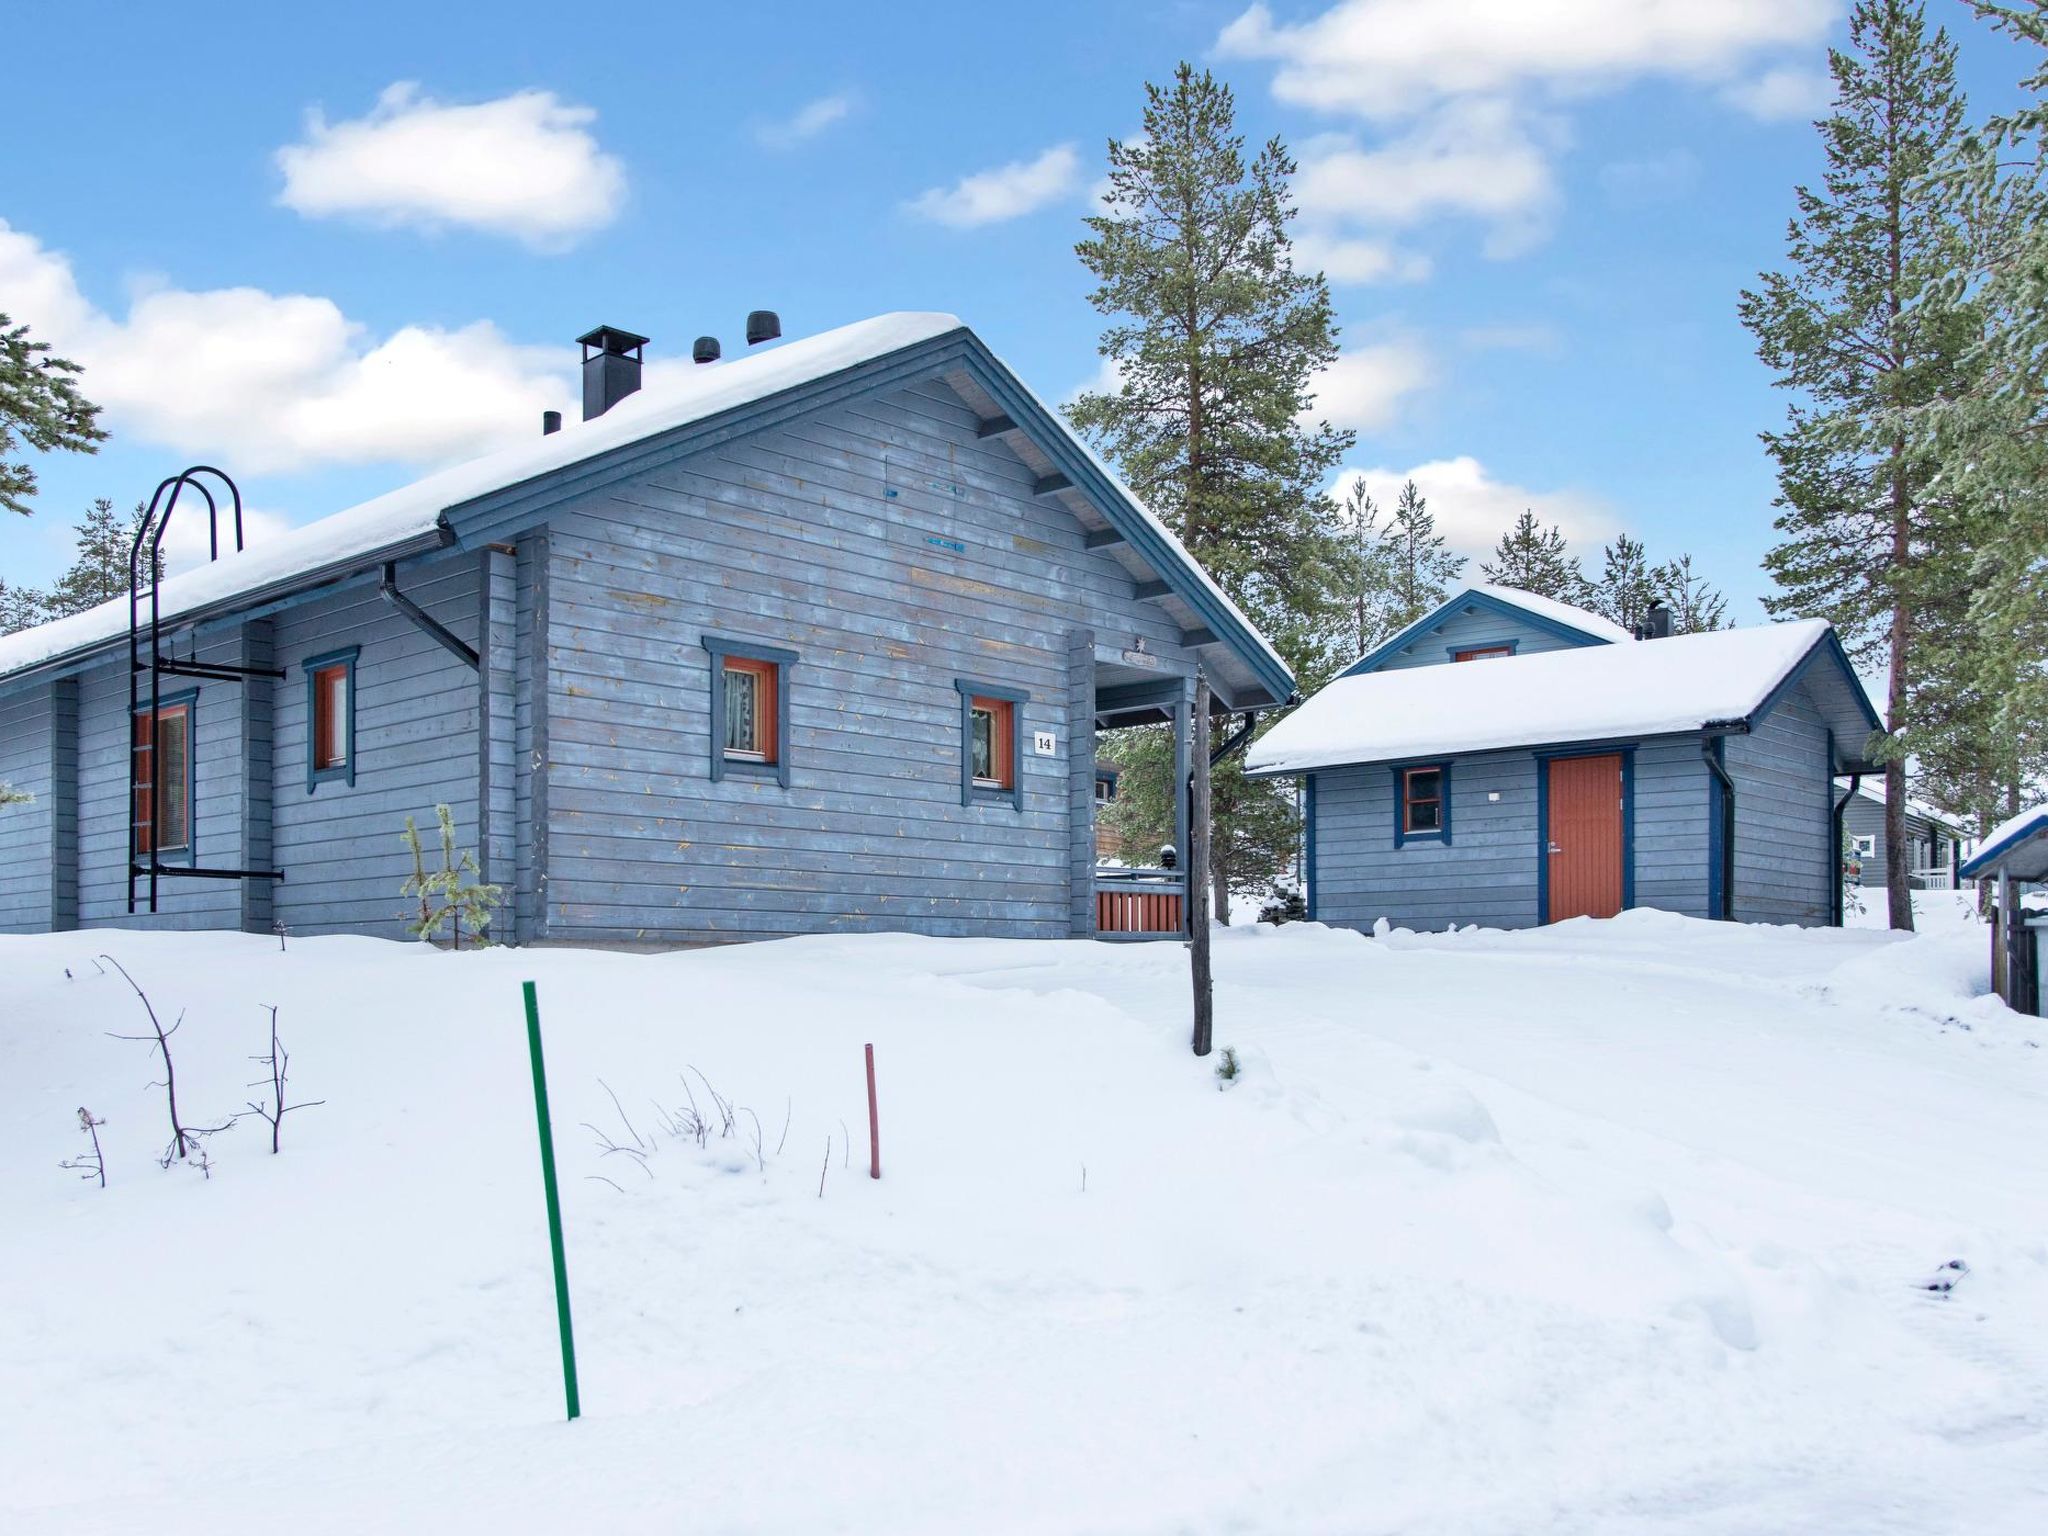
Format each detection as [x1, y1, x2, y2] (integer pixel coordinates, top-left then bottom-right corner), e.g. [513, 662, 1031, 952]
[0, 221, 571, 471]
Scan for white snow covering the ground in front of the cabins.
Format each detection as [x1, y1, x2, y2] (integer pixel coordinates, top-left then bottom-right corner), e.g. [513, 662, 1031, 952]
[0, 911, 2048, 1536]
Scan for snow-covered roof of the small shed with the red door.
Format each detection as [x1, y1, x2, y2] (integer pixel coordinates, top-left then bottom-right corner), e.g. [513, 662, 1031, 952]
[1245, 618, 1878, 774]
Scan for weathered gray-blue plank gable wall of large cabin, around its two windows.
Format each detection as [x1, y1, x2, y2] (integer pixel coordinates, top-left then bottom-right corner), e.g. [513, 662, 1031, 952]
[537, 379, 1186, 942]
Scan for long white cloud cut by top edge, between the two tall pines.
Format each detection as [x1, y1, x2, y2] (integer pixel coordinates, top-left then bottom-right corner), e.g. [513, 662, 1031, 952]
[1217, 0, 1841, 119]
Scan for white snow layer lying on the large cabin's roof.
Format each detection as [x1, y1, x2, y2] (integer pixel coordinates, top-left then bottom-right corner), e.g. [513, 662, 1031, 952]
[0, 311, 1292, 696]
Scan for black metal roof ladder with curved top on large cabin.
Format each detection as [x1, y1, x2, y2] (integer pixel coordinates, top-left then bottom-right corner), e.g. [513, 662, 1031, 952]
[129, 465, 285, 913]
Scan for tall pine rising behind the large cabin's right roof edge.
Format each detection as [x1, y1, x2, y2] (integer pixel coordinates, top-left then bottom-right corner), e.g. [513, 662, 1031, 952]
[1067, 63, 1356, 920]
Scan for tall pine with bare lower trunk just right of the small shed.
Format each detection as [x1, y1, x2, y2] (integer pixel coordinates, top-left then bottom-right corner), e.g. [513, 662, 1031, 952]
[1741, 0, 1976, 928]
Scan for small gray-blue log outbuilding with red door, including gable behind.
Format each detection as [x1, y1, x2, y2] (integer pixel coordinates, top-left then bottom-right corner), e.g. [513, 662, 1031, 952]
[1247, 586, 1878, 930]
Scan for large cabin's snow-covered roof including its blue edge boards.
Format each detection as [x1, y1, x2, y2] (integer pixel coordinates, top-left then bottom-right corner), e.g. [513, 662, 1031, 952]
[0, 311, 1292, 700]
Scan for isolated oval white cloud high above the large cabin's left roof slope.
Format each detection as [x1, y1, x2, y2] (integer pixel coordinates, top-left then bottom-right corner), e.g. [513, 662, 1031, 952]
[276, 82, 627, 250]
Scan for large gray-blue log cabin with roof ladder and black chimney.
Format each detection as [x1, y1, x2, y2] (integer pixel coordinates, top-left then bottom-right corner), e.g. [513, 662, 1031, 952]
[0, 313, 1292, 944]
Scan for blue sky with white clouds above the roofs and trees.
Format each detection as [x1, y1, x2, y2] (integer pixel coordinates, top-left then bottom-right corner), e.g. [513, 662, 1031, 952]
[0, 0, 2021, 623]
